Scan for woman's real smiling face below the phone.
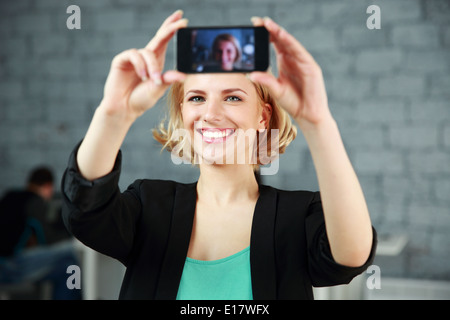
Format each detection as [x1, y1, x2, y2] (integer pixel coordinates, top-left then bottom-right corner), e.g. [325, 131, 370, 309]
[181, 74, 267, 164]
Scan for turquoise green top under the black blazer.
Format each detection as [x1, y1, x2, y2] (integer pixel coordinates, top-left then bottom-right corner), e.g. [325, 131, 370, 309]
[177, 247, 253, 300]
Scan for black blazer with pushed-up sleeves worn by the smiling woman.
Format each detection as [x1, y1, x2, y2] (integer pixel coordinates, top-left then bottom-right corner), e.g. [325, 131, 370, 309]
[62, 145, 376, 300]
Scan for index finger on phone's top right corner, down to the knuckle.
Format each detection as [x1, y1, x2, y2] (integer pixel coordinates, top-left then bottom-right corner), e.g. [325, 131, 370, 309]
[264, 17, 315, 62]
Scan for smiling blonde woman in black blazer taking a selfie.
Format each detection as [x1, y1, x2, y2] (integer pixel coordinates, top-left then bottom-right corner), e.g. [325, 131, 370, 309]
[62, 11, 376, 299]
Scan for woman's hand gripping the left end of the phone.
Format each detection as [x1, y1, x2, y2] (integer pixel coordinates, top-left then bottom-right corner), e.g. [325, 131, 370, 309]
[100, 10, 188, 122]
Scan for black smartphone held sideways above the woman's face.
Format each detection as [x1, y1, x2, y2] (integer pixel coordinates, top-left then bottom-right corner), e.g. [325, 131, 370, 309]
[177, 26, 269, 73]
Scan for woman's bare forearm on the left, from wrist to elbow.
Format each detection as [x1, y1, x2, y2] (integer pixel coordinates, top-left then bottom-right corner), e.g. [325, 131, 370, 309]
[77, 102, 133, 181]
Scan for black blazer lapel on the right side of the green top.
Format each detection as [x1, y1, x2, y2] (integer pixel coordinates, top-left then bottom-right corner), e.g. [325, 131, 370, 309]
[250, 185, 277, 300]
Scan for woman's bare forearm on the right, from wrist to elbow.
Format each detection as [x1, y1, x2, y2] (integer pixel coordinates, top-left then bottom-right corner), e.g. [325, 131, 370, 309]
[298, 116, 372, 266]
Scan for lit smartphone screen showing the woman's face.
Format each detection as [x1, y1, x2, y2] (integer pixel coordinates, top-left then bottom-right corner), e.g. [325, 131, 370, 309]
[192, 29, 255, 72]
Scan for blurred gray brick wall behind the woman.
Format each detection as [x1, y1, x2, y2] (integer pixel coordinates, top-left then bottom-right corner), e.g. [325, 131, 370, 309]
[0, 0, 450, 280]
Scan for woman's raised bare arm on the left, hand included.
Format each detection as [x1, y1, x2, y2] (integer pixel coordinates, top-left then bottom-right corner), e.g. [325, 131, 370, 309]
[77, 10, 187, 180]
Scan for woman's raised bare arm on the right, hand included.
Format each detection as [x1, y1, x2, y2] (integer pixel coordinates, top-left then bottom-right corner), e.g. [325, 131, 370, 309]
[250, 18, 373, 267]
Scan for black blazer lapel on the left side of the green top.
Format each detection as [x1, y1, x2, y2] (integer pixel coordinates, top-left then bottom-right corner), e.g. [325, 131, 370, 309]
[155, 182, 197, 300]
